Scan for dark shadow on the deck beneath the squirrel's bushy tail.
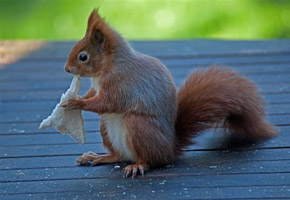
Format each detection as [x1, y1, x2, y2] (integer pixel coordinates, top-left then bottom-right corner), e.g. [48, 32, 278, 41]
[151, 134, 263, 175]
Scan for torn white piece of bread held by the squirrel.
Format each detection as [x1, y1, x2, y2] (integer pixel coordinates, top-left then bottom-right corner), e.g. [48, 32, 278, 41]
[39, 76, 86, 144]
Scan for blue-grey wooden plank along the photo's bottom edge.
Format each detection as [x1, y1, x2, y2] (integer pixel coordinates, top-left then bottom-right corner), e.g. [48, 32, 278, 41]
[0, 186, 290, 200]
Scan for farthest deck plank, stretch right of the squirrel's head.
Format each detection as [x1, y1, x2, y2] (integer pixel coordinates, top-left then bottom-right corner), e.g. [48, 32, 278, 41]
[108, 39, 290, 56]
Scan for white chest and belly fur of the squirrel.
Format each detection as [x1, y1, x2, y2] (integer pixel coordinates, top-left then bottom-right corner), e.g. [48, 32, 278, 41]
[91, 78, 136, 161]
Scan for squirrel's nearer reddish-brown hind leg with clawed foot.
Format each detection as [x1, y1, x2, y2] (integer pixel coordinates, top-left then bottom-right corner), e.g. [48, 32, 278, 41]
[123, 114, 175, 178]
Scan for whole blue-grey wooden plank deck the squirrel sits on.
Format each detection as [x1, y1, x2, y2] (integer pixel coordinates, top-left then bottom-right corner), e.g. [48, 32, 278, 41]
[0, 40, 290, 200]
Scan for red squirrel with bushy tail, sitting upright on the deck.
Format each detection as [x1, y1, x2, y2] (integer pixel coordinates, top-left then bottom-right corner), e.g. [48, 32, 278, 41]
[62, 10, 276, 177]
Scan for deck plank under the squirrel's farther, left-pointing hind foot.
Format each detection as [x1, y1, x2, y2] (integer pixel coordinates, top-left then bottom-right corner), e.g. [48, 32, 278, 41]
[0, 148, 290, 172]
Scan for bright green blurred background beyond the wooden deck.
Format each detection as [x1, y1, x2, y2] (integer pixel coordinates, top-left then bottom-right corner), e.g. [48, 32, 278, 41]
[0, 0, 290, 40]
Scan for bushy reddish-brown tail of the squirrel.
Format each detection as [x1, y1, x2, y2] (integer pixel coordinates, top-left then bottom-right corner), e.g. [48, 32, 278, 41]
[175, 67, 276, 150]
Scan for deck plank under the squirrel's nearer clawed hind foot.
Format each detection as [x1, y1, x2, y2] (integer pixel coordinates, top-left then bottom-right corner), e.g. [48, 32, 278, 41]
[0, 159, 290, 183]
